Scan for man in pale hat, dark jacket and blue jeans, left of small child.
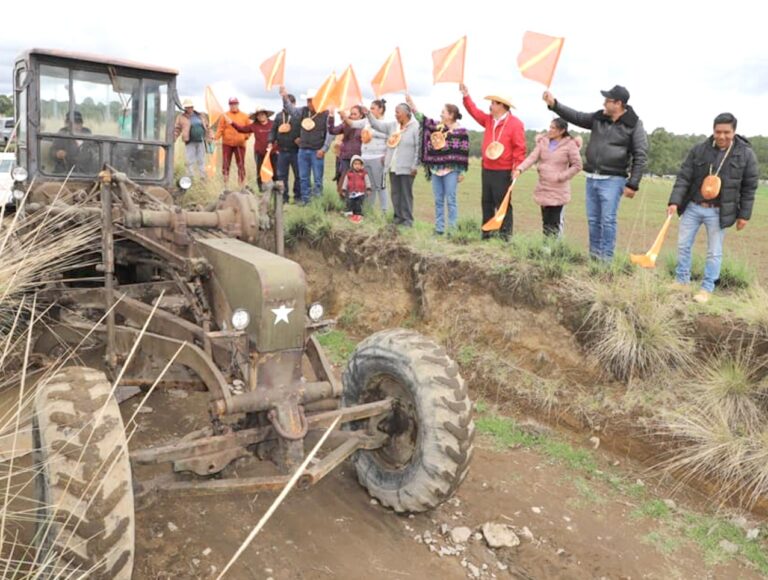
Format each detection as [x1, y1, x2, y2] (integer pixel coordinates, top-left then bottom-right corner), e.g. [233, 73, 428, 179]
[280, 87, 331, 204]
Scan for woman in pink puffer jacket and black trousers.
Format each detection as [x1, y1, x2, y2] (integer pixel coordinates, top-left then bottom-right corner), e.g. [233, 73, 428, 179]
[513, 118, 581, 236]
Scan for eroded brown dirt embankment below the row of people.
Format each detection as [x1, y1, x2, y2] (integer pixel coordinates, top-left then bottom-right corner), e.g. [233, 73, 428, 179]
[289, 231, 768, 513]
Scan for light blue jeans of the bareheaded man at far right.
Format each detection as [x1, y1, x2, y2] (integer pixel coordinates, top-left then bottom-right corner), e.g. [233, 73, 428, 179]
[675, 203, 725, 292]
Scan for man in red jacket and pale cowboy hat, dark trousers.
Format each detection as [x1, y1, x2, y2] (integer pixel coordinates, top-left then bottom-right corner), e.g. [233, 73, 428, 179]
[459, 83, 525, 240]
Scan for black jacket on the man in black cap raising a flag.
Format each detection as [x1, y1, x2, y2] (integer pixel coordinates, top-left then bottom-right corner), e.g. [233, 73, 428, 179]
[550, 101, 648, 191]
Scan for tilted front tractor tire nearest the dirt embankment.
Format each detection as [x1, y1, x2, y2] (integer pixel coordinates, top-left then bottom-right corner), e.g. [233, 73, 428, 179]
[342, 329, 475, 512]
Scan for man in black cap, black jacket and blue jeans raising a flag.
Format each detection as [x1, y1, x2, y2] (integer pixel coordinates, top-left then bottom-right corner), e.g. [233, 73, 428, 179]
[544, 85, 648, 261]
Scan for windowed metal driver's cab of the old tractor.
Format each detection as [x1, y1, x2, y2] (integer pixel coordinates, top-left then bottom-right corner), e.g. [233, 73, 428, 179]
[13, 49, 178, 199]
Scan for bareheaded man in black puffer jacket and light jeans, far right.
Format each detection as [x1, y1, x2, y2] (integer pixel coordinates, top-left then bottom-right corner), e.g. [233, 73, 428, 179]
[667, 113, 758, 304]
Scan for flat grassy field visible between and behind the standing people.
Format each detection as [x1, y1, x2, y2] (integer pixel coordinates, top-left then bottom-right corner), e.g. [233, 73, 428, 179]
[182, 150, 768, 284]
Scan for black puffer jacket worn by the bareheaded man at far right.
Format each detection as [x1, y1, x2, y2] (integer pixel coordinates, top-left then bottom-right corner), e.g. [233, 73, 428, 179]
[669, 135, 758, 228]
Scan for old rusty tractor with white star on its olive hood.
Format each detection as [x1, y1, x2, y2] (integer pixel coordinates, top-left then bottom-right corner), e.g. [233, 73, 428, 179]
[13, 49, 474, 578]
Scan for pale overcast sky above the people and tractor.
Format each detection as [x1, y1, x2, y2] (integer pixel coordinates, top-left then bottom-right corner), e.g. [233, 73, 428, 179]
[0, 0, 768, 135]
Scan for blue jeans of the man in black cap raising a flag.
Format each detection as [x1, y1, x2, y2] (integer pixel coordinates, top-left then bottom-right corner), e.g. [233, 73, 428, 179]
[587, 177, 627, 261]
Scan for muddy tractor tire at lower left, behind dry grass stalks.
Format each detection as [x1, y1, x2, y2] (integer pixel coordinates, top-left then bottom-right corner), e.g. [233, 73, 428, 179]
[33, 367, 135, 580]
